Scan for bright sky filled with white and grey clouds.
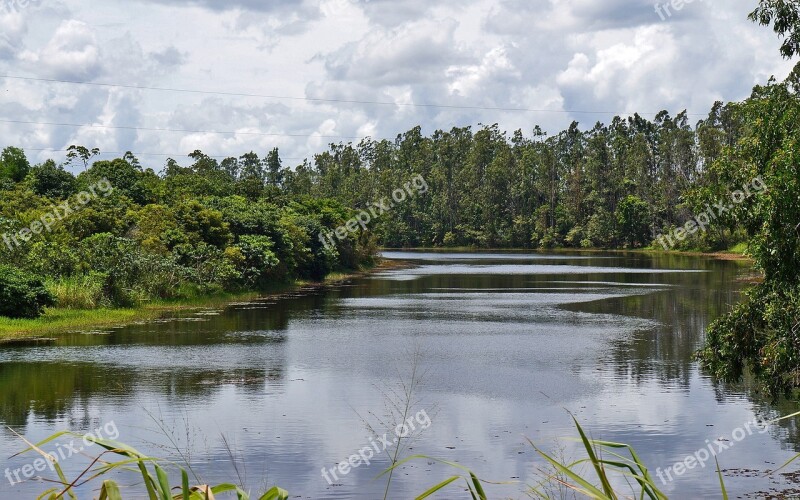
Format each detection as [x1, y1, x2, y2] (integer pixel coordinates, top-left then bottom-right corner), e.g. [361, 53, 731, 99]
[0, 0, 794, 171]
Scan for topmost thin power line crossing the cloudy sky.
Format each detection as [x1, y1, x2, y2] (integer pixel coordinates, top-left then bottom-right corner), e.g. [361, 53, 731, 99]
[0, 75, 706, 116]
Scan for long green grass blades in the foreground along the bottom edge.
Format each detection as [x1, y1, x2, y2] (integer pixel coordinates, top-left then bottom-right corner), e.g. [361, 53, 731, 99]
[12, 412, 800, 500]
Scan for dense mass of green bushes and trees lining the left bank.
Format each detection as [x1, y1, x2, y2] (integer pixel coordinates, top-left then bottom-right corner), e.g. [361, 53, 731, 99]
[0, 148, 376, 316]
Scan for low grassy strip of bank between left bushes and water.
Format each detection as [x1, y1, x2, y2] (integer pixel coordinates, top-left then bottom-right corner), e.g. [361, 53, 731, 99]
[0, 261, 399, 344]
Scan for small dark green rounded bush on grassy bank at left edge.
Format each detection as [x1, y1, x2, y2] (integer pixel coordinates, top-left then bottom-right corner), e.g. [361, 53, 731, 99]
[0, 265, 55, 318]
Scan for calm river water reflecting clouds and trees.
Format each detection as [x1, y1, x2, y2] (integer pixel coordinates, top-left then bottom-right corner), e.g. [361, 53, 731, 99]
[0, 252, 800, 499]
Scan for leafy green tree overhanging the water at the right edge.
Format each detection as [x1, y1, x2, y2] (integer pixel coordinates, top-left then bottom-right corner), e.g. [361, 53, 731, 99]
[699, 65, 800, 394]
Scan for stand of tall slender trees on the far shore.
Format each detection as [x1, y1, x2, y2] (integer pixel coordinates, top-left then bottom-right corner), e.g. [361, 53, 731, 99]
[290, 103, 743, 249]
